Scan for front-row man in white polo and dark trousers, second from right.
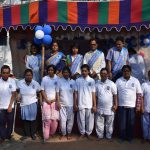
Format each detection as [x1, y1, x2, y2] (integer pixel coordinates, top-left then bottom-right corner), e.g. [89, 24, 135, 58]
[116, 65, 142, 142]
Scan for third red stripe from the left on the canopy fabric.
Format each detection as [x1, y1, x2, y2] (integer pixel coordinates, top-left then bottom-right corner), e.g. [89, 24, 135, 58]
[88, 2, 98, 24]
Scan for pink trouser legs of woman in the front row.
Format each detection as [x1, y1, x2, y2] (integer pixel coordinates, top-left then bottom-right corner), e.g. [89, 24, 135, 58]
[43, 120, 58, 140]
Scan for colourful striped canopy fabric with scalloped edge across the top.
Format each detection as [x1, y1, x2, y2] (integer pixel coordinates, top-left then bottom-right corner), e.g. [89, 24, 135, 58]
[0, 0, 150, 29]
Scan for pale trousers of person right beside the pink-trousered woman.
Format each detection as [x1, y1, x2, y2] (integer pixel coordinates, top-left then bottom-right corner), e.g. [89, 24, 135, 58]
[60, 107, 74, 135]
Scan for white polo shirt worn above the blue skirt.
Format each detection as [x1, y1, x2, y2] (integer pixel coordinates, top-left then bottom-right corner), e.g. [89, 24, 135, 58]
[17, 79, 41, 106]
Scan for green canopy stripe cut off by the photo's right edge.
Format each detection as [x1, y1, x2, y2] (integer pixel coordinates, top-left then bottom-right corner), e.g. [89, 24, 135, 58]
[142, 0, 150, 21]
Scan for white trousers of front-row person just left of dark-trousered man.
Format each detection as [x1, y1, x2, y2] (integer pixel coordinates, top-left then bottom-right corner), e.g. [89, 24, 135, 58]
[95, 113, 114, 139]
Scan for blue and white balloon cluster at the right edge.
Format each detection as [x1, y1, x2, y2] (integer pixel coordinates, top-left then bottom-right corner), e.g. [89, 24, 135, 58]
[140, 34, 150, 47]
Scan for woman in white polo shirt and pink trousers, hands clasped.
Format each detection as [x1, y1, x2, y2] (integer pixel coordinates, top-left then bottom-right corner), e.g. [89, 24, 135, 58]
[41, 65, 59, 141]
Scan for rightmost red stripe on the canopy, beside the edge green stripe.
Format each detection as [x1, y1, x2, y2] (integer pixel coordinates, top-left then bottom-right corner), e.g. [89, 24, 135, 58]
[131, 0, 142, 23]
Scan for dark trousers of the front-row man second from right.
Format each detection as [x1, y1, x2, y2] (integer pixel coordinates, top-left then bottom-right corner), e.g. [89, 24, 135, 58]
[118, 107, 135, 141]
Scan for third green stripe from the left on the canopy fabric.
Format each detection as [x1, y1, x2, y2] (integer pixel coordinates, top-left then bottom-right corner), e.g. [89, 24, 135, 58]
[98, 2, 109, 24]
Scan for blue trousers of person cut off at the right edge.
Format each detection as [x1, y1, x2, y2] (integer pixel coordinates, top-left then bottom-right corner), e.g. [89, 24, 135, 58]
[142, 112, 150, 140]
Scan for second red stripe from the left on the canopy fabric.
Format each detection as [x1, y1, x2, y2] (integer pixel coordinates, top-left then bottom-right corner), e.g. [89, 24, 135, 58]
[47, 0, 58, 22]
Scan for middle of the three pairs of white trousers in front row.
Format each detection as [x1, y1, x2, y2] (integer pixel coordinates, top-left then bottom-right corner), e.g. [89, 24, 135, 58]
[77, 108, 94, 135]
